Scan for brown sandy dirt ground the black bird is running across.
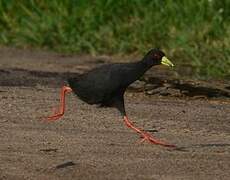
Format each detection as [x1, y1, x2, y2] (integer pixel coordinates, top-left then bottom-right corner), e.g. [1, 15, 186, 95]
[0, 48, 230, 180]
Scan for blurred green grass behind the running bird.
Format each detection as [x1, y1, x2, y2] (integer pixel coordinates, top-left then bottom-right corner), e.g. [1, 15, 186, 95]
[0, 0, 230, 79]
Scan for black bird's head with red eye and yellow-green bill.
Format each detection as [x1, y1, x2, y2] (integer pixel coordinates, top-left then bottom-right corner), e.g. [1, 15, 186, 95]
[144, 49, 174, 67]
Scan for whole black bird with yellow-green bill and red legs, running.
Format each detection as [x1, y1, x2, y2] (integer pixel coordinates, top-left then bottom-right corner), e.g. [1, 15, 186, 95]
[44, 49, 174, 147]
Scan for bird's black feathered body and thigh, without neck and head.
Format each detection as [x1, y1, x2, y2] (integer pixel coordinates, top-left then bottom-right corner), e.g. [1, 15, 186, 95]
[68, 63, 144, 115]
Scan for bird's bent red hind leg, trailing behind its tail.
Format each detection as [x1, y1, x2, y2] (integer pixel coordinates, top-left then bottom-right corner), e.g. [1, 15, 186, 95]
[46, 86, 72, 121]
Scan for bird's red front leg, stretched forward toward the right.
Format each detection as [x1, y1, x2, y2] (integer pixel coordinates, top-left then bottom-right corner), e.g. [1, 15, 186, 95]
[124, 116, 176, 147]
